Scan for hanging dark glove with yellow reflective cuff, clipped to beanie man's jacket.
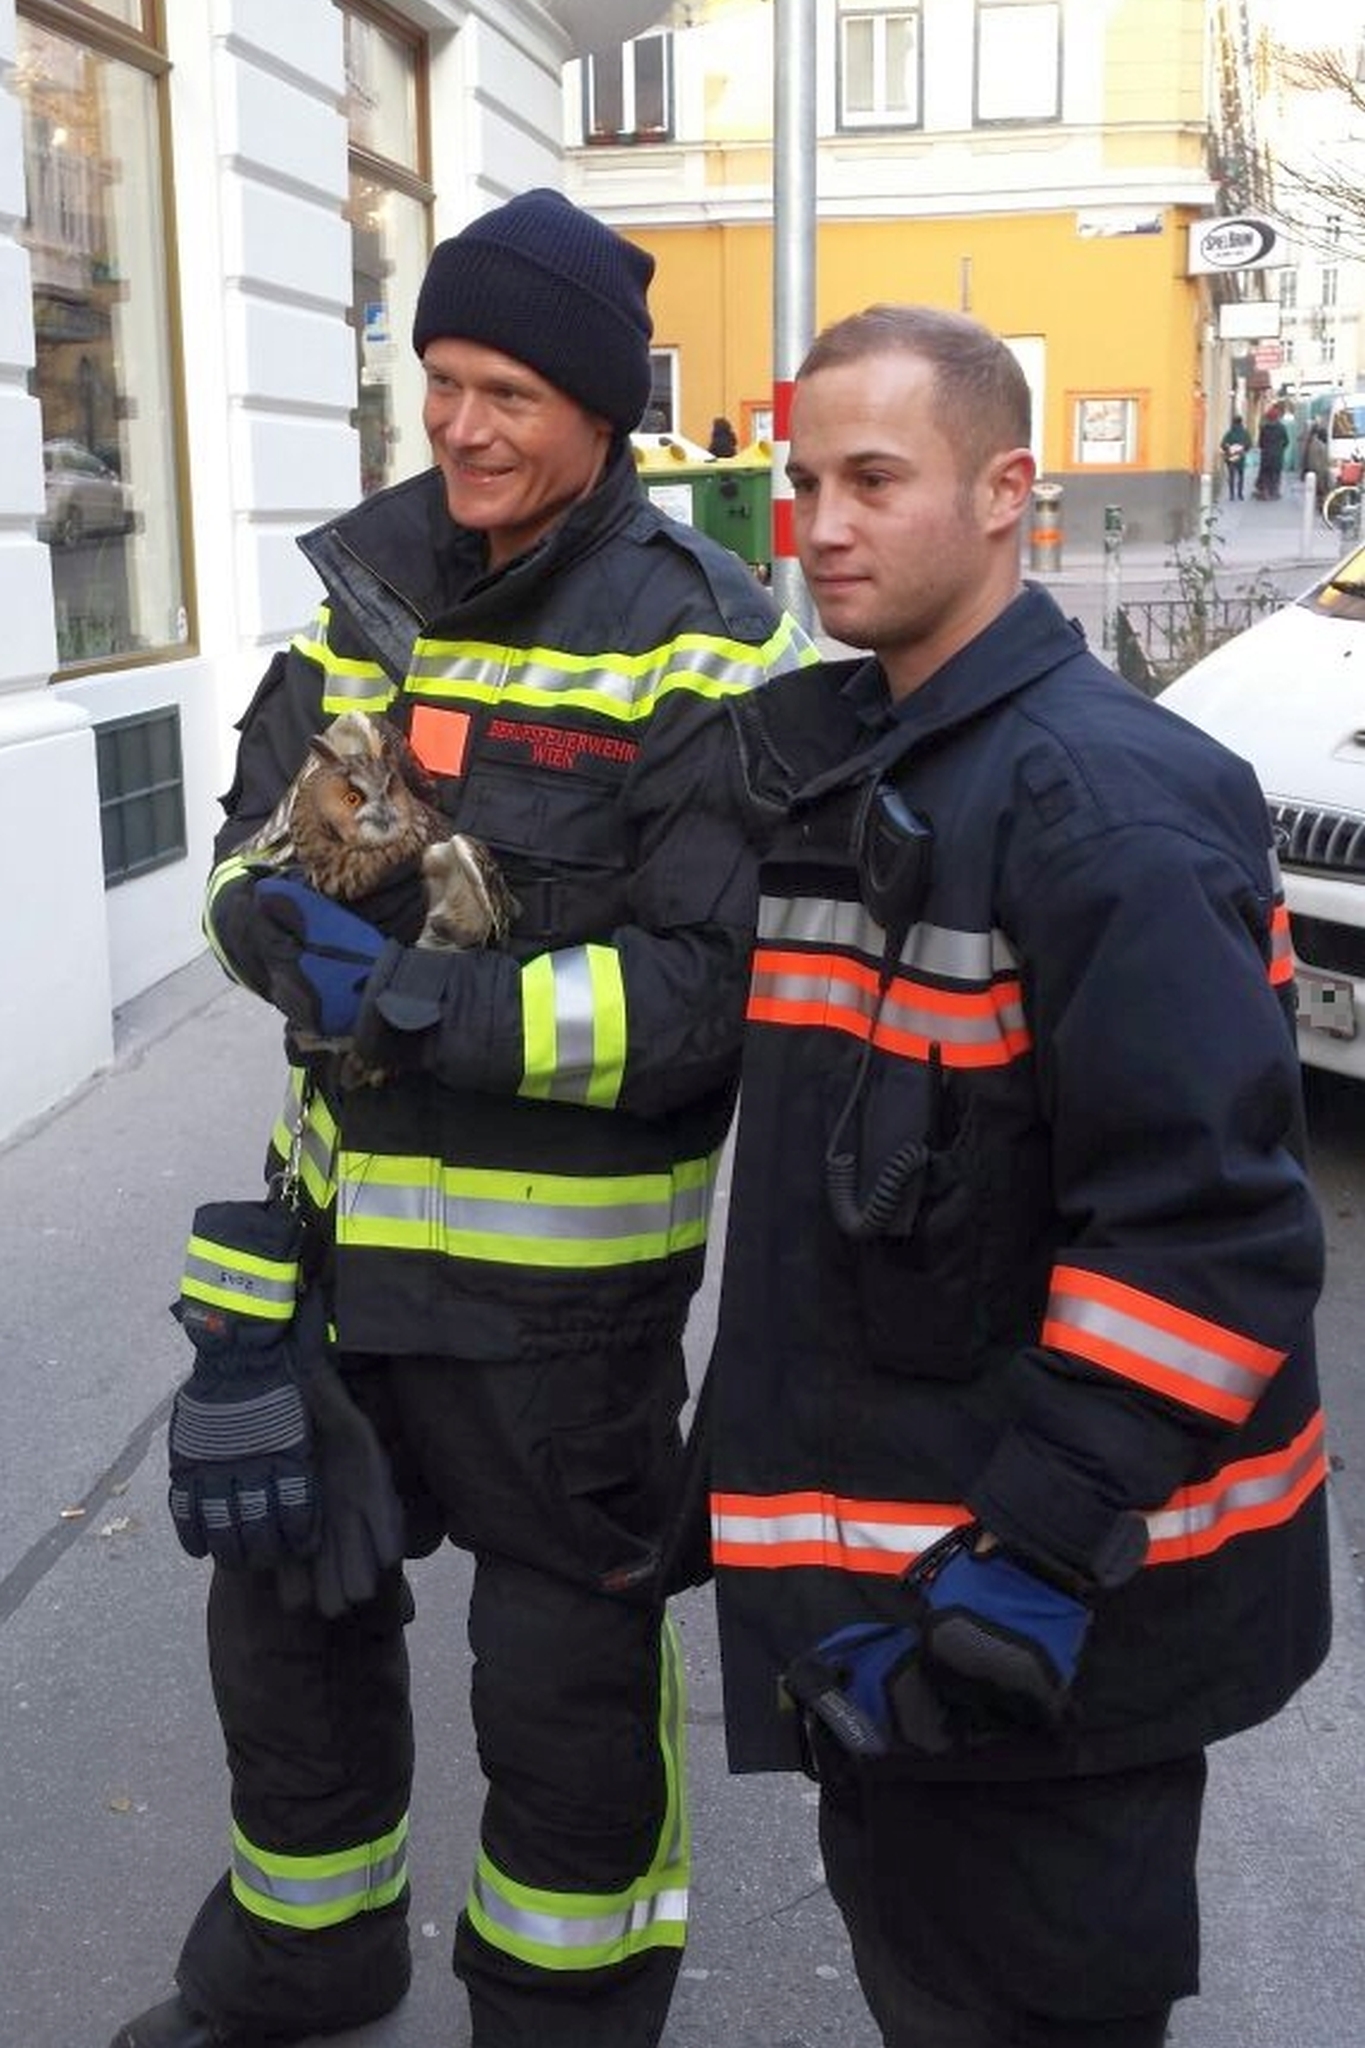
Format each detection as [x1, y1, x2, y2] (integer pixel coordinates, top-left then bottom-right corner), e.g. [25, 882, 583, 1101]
[168, 1202, 321, 1569]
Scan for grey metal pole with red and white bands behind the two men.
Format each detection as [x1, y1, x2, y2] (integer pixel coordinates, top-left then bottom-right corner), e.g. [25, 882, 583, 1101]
[772, 0, 817, 631]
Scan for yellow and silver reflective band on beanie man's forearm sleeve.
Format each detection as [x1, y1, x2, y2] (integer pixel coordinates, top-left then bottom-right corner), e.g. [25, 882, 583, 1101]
[518, 946, 626, 1110]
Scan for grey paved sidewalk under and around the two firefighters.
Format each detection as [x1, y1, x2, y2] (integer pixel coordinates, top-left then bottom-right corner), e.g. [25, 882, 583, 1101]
[0, 961, 1365, 2048]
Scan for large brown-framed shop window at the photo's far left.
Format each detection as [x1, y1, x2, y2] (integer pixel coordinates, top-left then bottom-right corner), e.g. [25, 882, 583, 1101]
[14, 0, 188, 672]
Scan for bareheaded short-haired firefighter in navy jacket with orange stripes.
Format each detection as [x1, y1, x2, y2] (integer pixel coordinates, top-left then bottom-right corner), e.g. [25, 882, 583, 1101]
[710, 307, 1330, 2048]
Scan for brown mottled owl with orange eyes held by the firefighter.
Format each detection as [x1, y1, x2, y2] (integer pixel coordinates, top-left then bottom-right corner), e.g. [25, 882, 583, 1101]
[241, 711, 518, 950]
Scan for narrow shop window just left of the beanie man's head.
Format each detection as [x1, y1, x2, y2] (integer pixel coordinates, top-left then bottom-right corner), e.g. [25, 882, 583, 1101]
[342, 0, 432, 494]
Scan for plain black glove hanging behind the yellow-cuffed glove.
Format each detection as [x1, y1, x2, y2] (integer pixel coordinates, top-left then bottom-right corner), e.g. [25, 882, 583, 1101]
[276, 1341, 403, 1620]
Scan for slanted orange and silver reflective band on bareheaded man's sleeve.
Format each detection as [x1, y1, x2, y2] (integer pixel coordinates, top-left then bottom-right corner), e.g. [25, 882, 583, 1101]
[1042, 1266, 1285, 1423]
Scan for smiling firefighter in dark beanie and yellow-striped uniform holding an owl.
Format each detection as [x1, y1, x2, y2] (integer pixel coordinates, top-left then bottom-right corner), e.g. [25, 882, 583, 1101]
[113, 190, 814, 2048]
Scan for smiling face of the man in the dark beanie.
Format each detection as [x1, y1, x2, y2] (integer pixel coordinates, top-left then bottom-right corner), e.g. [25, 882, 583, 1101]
[422, 336, 612, 569]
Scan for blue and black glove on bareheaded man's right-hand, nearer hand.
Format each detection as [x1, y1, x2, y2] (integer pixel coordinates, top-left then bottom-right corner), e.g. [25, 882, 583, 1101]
[900, 1528, 1091, 1741]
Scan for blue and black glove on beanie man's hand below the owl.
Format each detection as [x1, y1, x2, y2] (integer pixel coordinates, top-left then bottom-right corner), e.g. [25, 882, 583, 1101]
[252, 874, 388, 1042]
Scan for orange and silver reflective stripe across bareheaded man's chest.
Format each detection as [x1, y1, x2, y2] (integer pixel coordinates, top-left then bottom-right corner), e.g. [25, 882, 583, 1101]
[747, 946, 1031, 1067]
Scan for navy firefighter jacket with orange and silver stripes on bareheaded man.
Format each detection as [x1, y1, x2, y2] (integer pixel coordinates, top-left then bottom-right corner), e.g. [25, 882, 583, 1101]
[712, 586, 1330, 1776]
